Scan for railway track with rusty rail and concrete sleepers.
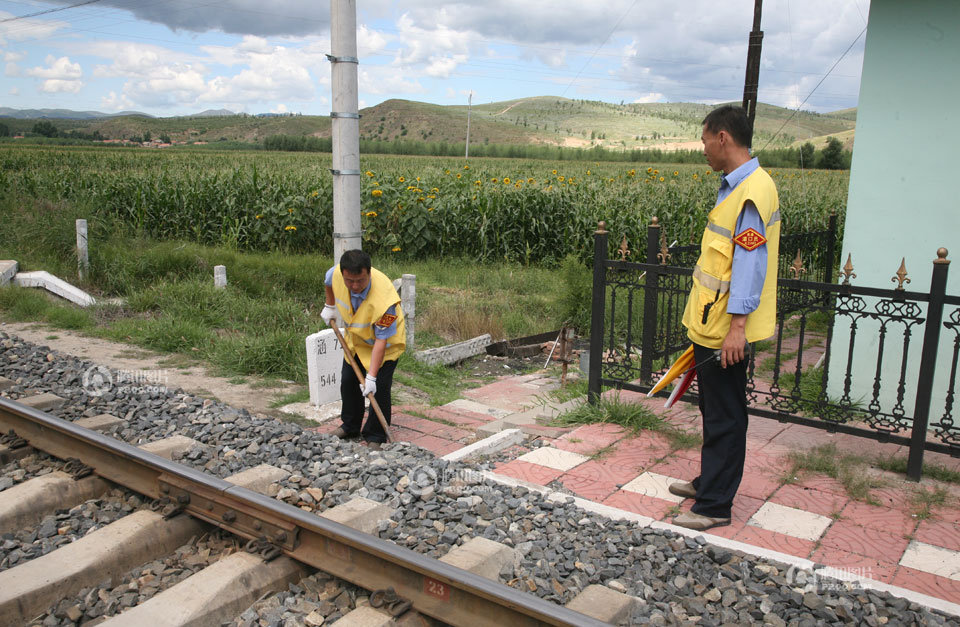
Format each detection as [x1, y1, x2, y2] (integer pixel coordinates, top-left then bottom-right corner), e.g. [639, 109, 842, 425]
[0, 398, 604, 625]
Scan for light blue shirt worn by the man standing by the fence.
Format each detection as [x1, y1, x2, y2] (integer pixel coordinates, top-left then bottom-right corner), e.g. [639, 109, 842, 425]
[717, 158, 767, 314]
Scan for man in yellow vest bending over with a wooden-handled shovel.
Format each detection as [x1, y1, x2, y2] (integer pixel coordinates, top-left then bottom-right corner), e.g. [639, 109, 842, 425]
[320, 250, 407, 449]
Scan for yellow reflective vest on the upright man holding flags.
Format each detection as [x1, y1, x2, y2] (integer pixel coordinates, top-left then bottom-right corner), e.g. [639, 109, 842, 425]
[683, 168, 780, 348]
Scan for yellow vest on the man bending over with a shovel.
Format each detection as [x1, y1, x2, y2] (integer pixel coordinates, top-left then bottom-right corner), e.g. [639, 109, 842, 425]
[333, 264, 407, 369]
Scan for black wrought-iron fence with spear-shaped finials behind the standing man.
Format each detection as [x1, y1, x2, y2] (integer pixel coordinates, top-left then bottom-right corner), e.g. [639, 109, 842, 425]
[589, 217, 960, 480]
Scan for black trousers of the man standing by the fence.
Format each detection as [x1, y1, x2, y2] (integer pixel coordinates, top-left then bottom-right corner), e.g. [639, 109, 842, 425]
[691, 344, 747, 518]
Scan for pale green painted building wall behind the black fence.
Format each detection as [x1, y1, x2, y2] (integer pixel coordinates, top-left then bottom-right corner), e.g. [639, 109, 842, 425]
[828, 0, 960, 442]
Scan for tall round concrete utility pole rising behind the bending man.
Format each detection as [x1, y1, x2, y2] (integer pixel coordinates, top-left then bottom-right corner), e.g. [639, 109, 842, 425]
[327, 0, 362, 263]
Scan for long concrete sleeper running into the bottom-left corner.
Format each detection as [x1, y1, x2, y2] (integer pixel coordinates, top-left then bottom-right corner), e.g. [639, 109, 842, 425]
[0, 510, 204, 625]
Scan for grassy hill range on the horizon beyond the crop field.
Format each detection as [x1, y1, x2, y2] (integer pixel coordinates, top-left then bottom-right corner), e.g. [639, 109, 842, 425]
[0, 96, 856, 150]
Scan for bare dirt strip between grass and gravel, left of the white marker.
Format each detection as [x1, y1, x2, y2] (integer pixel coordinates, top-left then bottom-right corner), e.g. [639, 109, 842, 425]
[0, 322, 304, 417]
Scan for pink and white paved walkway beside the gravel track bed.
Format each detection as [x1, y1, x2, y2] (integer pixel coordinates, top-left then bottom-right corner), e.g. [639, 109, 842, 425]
[320, 374, 960, 603]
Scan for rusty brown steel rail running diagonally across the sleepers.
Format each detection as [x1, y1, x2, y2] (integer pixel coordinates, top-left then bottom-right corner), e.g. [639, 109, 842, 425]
[0, 398, 607, 627]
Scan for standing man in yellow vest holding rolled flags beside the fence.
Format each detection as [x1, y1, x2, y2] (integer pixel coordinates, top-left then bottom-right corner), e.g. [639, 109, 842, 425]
[670, 105, 780, 530]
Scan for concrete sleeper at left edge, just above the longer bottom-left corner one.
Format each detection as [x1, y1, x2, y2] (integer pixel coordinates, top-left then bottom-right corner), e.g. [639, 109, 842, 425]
[0, 470, 109, 534]
